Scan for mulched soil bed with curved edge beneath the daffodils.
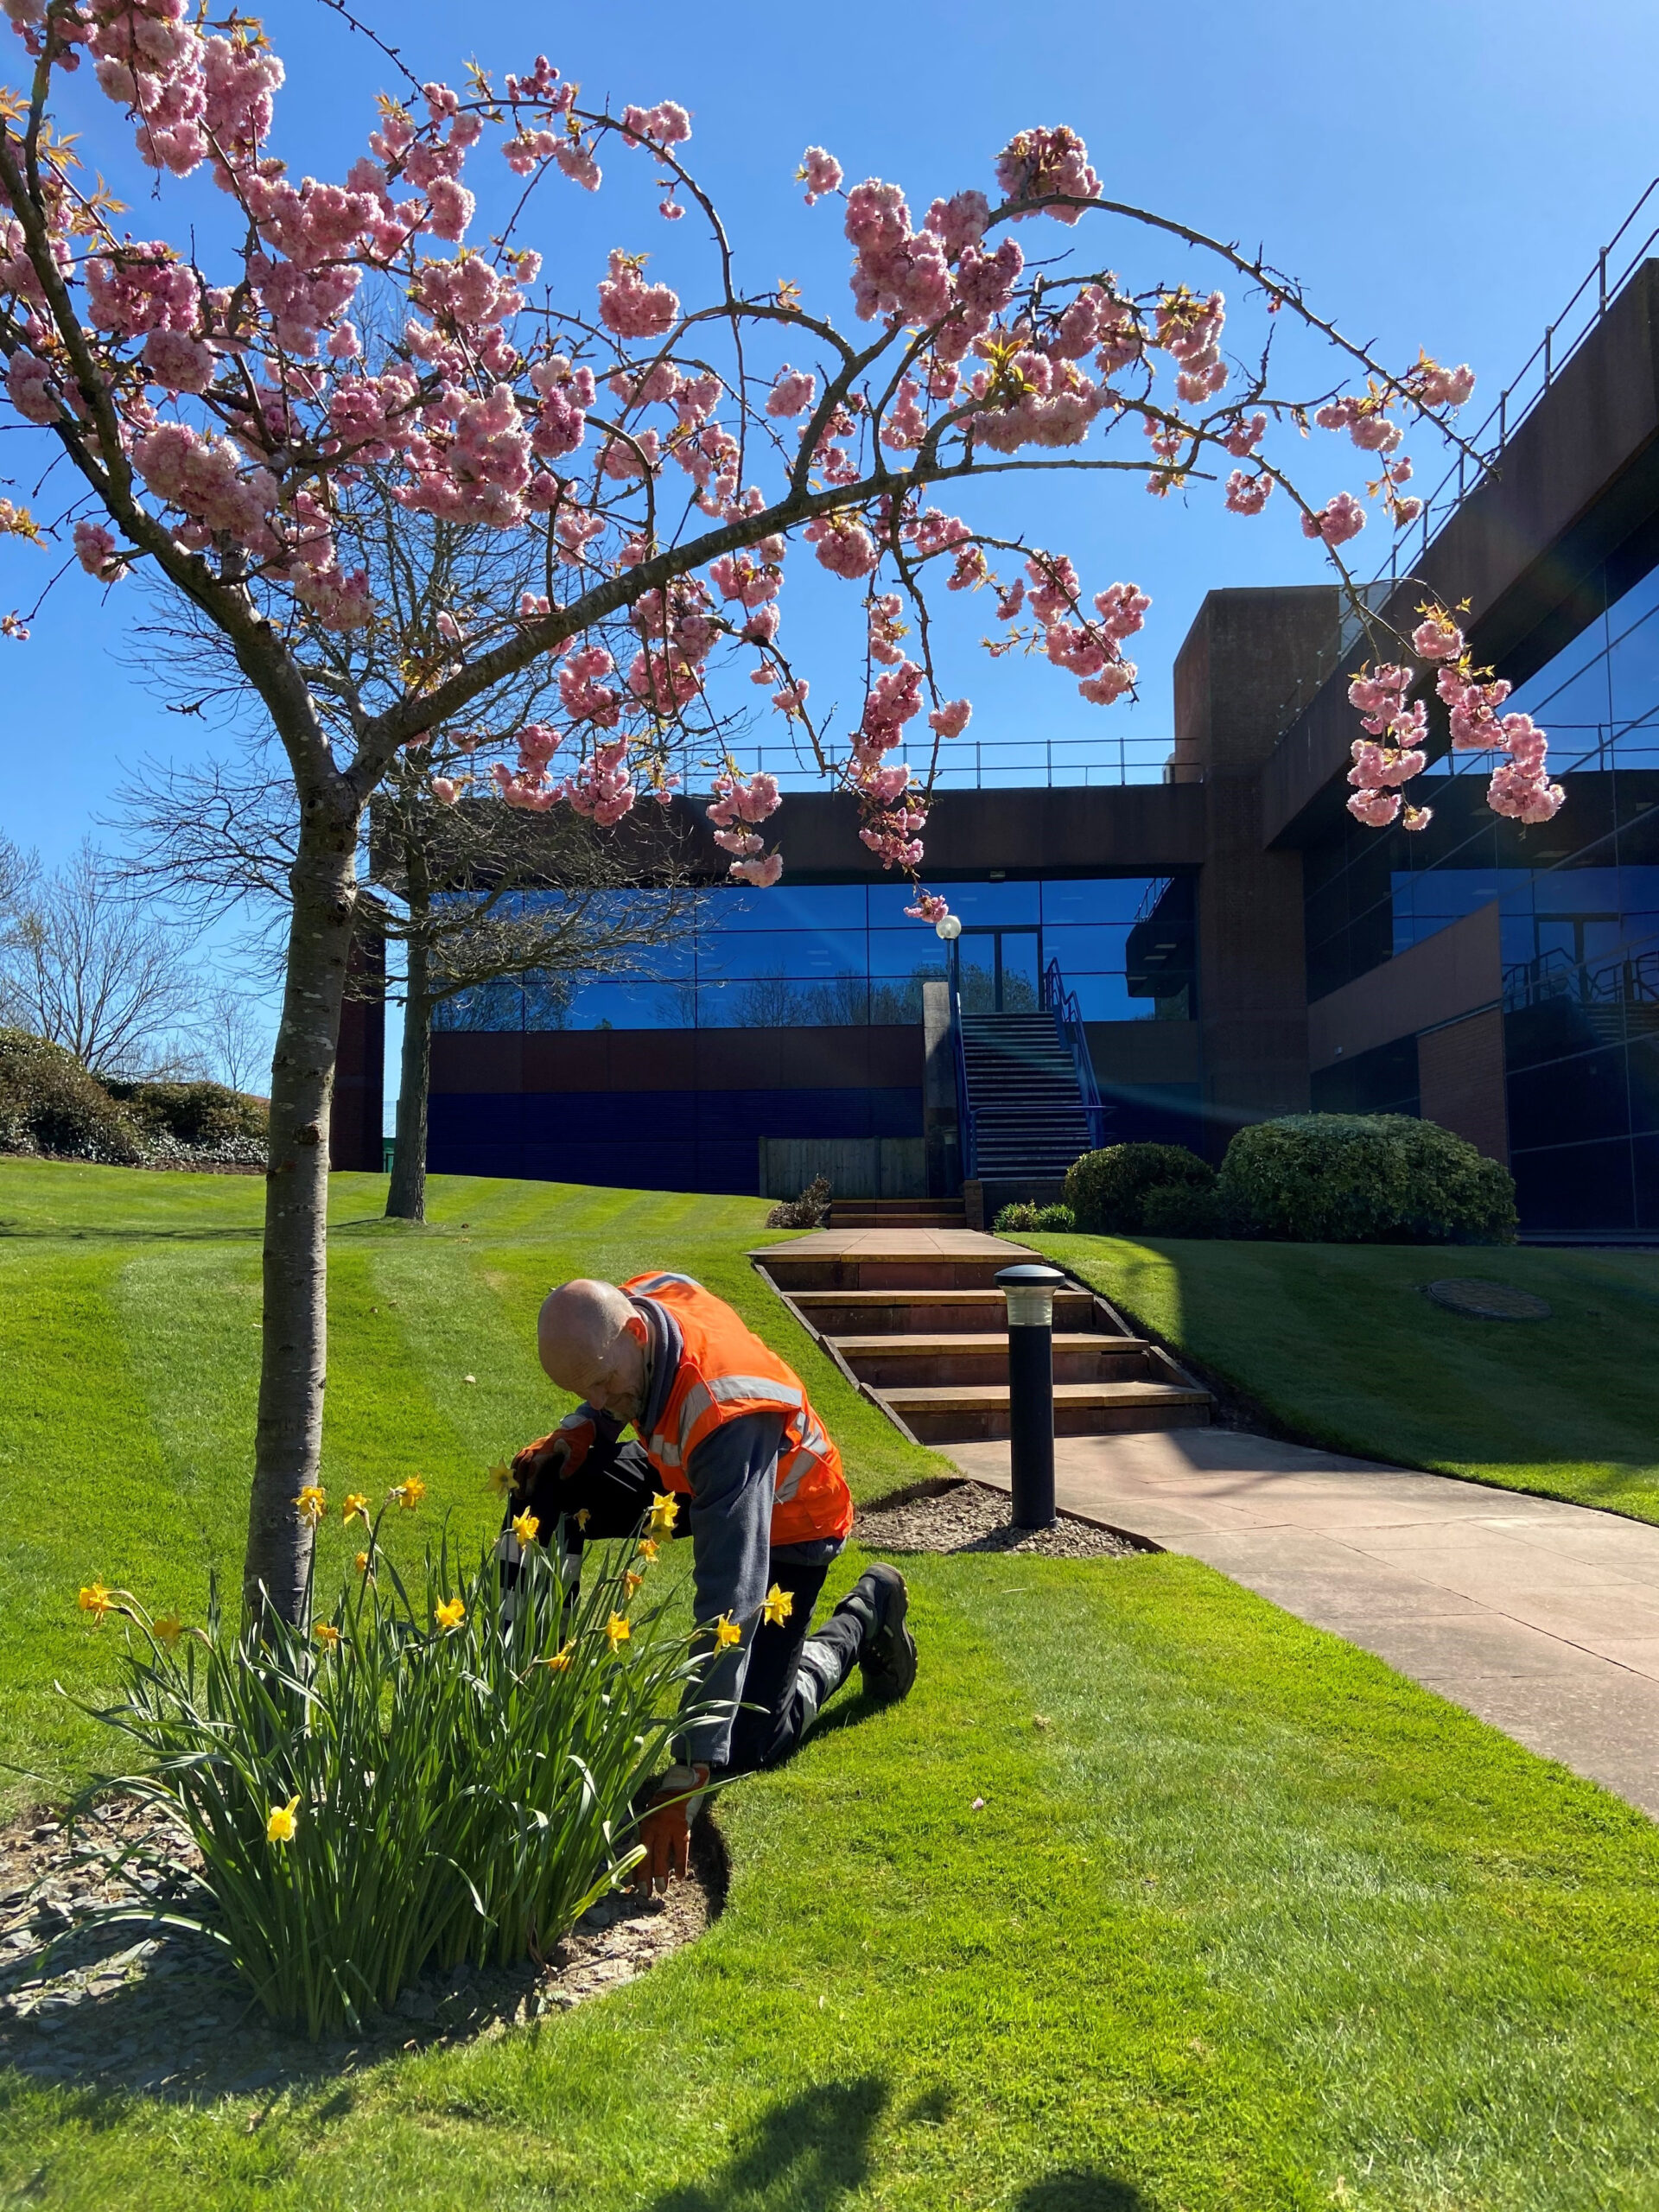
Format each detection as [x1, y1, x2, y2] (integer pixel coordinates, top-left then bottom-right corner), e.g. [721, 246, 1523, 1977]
[0, 1798, 728, 2096]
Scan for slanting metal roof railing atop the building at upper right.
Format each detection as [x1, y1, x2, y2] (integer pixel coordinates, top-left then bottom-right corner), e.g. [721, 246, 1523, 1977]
[1279, 177, 1659, 736]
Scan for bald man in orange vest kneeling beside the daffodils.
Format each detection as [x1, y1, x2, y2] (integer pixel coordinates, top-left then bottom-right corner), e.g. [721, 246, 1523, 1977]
[509, 1274, 916, 1883]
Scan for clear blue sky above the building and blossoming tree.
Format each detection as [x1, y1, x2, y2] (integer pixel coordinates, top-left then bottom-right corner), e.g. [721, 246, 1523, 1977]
[0, 0, 1659, 1088]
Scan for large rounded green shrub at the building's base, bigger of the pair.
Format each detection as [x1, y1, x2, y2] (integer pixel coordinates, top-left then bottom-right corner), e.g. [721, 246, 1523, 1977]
[1219, 1113, 1516, 1243]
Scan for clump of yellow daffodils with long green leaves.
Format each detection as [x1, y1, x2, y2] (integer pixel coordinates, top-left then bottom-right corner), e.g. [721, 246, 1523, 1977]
[79, 1476, 721, 2035]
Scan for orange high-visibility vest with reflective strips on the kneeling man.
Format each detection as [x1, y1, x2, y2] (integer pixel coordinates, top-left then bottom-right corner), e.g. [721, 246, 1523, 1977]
[621, 1274, 852, 1548]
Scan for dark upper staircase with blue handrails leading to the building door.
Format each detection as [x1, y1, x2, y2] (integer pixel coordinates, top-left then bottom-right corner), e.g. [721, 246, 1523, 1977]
[957, 1008, 1106, 1184]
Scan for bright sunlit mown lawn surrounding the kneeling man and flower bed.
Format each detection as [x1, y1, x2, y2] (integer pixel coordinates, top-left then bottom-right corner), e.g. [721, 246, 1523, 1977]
[0, 1164, 1659, 2212]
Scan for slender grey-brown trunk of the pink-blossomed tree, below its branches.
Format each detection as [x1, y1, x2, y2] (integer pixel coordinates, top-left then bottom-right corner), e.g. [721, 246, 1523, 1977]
[244, 797, 359, 1621]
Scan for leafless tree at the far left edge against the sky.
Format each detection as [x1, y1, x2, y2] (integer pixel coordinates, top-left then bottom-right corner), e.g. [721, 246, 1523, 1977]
[0, 842, 194, 1077]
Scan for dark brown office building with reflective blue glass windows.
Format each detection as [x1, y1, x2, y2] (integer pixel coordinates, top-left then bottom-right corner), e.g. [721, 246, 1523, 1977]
[332, 261, 1659, 1239]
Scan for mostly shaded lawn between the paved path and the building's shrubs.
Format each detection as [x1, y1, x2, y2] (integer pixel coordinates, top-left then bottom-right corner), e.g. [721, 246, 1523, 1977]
[1033, 1236, 1659, 1522]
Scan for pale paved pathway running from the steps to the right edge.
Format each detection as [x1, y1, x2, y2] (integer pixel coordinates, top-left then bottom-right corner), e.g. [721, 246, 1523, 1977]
[947, 1429, 1659, 1818]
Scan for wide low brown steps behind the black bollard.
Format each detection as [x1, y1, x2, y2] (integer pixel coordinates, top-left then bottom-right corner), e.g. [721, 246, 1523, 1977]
[750, 1230, 1212, 1445]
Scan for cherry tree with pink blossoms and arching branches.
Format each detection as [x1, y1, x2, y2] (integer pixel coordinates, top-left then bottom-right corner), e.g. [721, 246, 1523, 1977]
[0, 0, 1560, 1615]
